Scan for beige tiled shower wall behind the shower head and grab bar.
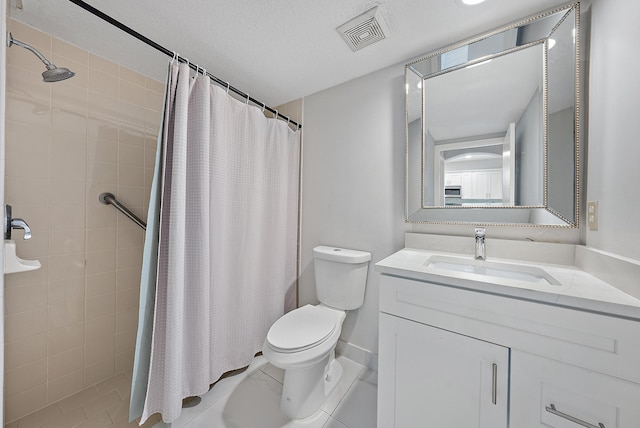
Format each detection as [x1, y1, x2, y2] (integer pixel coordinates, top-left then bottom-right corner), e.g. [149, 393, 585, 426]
[5, 20, 164, 422]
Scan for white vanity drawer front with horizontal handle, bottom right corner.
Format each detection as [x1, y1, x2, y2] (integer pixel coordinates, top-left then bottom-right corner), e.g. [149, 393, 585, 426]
[510, 350, 640, 428]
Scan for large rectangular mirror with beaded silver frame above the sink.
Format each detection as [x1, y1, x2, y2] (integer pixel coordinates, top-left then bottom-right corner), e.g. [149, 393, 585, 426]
[405, 3, 580, 227]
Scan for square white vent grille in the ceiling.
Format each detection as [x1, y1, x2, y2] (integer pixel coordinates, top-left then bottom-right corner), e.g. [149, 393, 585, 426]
[336, 6, 390, 52]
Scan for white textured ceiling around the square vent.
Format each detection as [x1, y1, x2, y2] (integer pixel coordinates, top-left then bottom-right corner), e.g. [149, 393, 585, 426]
[10, 0, 562, 106]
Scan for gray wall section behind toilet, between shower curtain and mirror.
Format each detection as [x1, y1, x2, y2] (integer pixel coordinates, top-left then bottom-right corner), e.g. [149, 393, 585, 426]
[299, 66, 405, 353]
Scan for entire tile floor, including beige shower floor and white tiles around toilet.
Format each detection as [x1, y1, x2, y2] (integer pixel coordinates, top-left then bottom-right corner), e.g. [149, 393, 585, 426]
[5, 356, 378, 428]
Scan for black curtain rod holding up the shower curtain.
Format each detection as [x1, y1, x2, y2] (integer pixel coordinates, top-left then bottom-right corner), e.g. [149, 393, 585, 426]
[69, 0, 302, 129]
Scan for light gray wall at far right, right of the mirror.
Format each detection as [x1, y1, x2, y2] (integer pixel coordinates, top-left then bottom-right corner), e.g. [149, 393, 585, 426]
[586, 0, 640, 260]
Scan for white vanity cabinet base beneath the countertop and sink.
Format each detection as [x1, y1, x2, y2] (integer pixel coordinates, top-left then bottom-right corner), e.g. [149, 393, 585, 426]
[378, 274, 640, 428]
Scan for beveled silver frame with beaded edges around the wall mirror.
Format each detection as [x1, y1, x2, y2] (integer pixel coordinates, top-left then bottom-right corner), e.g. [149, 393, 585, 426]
[405, 2, 582, 228]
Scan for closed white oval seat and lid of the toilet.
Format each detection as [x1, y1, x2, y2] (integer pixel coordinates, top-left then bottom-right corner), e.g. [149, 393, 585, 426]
[266, 305, 341, 353]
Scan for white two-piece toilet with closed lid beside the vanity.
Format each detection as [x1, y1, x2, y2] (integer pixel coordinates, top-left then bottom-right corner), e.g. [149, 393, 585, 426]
[262, 246, 371, 419]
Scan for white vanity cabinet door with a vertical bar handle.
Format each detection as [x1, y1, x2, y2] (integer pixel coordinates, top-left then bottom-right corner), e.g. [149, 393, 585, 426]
[378, 313, 509, 428]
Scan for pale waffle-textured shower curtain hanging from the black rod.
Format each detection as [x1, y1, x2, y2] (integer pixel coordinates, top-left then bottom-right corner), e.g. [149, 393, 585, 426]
[130, 60, 300, 422]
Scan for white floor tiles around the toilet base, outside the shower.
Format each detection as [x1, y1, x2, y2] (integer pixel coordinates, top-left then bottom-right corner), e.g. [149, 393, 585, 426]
[155, 356, 378, 428]
